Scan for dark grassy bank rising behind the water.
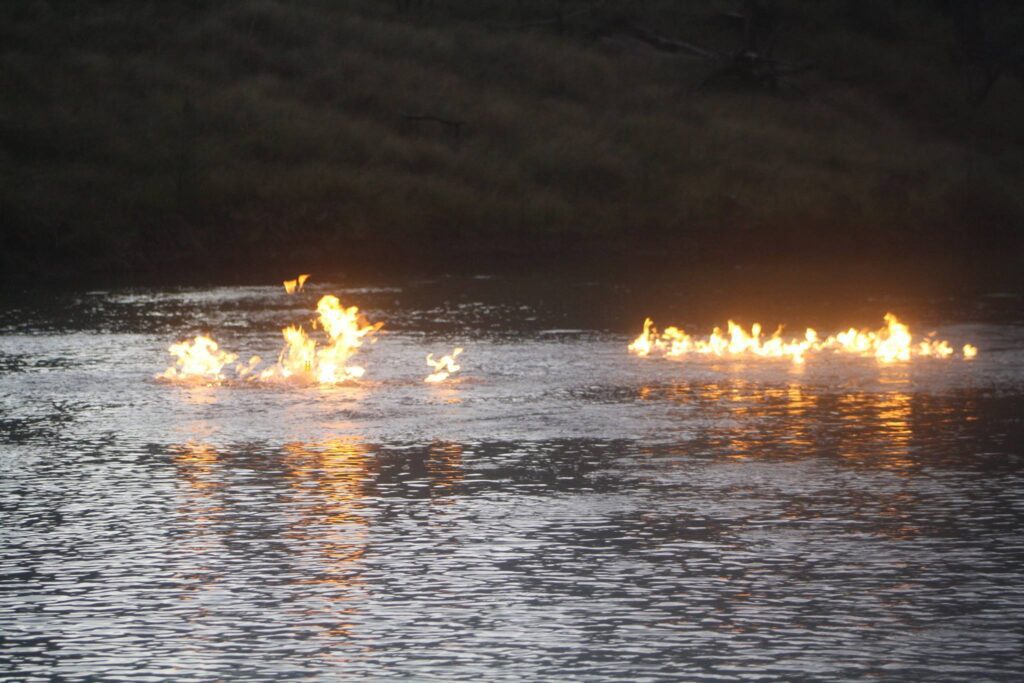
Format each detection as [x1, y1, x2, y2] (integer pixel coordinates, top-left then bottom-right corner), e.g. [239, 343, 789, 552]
[0, 0, 1024, 279]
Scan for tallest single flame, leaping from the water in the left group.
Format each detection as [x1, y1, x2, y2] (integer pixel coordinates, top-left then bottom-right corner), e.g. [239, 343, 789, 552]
[257, 294, 384, 384]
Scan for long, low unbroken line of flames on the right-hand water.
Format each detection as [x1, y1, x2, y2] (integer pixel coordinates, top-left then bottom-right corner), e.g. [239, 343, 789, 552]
[629, 313, 978, 362]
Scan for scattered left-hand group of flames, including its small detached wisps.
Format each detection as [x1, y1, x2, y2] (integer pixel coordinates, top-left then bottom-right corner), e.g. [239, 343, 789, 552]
[156, 274, 463, 384]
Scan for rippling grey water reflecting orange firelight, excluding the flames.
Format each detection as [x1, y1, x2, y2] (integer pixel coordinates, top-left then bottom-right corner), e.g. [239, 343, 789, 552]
[0, 280, 1024, 681]
